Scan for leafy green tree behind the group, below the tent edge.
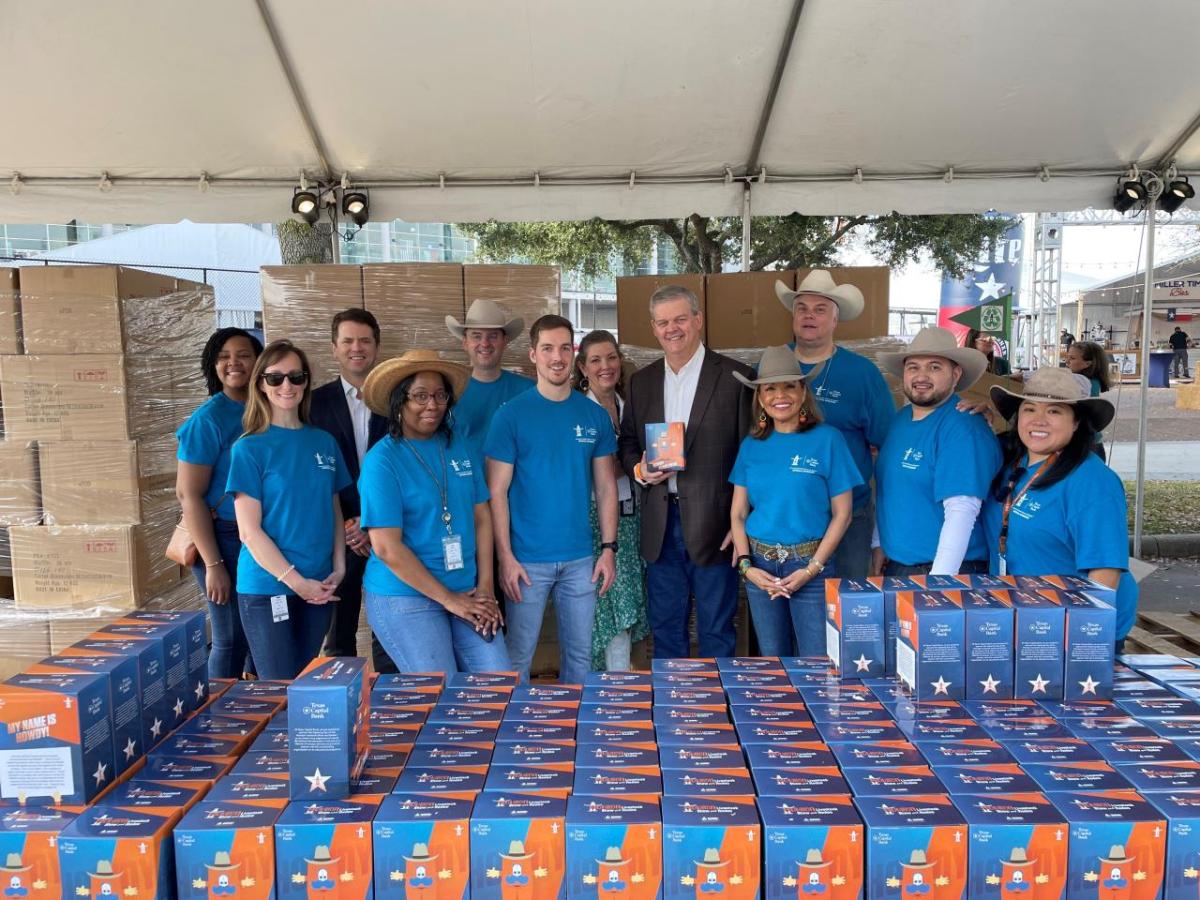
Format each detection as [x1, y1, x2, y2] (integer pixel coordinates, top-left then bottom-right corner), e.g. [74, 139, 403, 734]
[458, 212, 1012, 280]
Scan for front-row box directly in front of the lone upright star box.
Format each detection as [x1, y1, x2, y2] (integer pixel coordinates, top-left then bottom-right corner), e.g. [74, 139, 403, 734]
[275, 800, 378, 900]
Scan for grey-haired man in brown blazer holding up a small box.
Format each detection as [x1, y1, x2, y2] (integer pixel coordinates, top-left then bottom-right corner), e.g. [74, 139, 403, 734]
[618, 286, 752, 659]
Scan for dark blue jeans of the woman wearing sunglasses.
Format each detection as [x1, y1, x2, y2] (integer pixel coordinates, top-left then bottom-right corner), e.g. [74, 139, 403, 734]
[238, 594, 334, 680]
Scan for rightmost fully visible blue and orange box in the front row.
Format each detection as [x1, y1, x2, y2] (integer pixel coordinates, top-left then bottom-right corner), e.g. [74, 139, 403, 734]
[1048, 791, 1166, 900]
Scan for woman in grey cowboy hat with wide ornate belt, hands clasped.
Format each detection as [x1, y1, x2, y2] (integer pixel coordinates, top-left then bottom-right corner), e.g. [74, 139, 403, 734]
[730, 347, 863, 656]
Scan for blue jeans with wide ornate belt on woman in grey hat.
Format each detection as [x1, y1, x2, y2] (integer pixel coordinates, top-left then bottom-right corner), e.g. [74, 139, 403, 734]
[746, 553, 838, 656]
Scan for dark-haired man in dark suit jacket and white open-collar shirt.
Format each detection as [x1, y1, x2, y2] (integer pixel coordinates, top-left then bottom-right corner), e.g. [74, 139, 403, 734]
[308, 308, 396, 672]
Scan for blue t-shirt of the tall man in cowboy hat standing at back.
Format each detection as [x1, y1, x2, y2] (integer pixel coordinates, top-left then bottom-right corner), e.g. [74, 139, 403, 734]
[788, 341, 896, 510]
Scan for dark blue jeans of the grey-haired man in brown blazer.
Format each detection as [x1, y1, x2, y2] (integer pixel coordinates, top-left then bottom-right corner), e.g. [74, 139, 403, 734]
[646, 503, 738, 659]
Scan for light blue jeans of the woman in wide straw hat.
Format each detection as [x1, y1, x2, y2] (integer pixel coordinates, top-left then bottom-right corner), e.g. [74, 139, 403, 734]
[362, 590, 512, 674]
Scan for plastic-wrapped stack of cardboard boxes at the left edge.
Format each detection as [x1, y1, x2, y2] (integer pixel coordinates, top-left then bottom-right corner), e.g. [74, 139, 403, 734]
[0, 265, 215, 640]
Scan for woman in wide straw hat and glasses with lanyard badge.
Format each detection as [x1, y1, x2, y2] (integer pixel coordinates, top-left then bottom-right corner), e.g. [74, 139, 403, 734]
[359, 350, 510, 674]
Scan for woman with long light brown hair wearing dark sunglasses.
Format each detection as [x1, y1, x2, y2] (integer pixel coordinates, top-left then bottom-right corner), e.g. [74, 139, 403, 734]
[227, 341, 350, 679]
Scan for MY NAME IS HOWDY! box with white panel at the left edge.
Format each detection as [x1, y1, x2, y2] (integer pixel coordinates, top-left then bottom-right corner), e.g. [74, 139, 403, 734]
[0, 674, 116, 805]
